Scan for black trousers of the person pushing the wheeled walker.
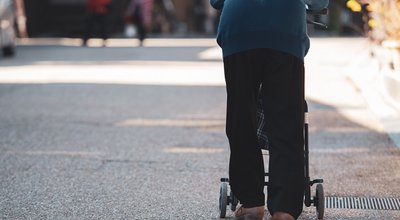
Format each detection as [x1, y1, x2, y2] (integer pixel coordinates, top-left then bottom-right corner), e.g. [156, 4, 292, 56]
[224, 49, 304, 218]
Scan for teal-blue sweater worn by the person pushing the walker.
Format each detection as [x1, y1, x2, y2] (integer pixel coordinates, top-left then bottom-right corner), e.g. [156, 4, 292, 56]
[210, 0, 329, 60]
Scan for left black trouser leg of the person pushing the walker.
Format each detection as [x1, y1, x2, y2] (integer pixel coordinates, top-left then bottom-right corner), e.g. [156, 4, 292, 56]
[224, 51, 265, 207]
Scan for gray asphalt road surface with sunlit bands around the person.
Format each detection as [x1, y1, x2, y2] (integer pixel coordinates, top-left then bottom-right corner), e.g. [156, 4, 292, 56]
[0, 38, 400, 220]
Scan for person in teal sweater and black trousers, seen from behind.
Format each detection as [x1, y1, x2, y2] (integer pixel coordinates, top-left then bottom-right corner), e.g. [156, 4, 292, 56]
[210, 0, 328, 220]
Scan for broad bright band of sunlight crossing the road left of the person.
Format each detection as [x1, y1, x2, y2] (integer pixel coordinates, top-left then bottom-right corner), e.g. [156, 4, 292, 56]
[0, 62, 225, 86]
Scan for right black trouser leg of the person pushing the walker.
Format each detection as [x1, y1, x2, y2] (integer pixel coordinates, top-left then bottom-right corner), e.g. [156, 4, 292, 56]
[262, 49, 304, 218]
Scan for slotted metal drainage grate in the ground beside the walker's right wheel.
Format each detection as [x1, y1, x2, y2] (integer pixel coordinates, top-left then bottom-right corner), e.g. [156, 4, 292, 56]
[325, 197, 400, 210]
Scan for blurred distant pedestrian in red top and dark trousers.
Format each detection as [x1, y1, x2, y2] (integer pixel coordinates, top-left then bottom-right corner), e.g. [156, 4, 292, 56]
[83, 0, 112, 46]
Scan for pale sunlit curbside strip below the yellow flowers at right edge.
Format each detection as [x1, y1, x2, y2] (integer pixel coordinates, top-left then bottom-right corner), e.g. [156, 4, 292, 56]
[347, 40, 400, 148]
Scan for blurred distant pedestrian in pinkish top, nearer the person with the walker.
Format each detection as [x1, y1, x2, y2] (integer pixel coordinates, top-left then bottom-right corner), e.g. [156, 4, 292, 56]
[125, 0, 154, 46]
